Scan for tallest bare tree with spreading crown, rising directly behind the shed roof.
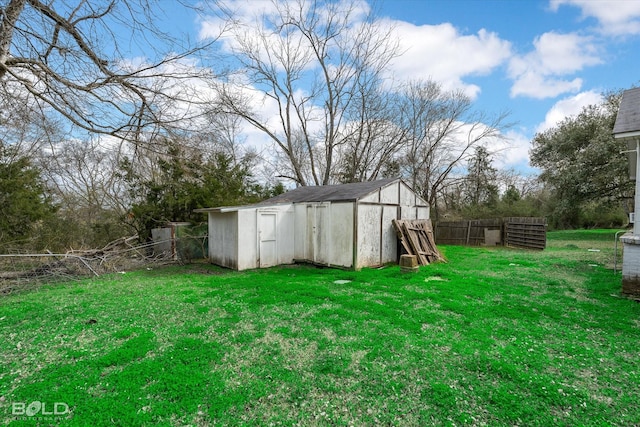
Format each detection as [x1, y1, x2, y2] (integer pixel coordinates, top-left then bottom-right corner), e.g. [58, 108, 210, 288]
[210, 0, 397, 185]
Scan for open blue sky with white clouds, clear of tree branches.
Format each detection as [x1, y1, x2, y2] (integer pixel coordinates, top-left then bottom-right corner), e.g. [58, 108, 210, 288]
[156, 0, 640, 173]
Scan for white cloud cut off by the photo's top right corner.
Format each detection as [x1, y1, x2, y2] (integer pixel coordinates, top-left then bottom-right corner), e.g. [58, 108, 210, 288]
[550, 0, 640, 35]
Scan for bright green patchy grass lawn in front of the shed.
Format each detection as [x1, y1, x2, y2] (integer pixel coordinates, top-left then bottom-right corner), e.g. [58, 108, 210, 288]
[0, 230, 640, 426]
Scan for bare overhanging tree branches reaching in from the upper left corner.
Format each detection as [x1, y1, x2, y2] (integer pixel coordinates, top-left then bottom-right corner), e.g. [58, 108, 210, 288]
[0, 0, 215, 144]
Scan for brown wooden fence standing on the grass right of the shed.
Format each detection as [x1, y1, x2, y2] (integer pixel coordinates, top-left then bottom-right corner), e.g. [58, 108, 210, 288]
[435, 217, 547, 249]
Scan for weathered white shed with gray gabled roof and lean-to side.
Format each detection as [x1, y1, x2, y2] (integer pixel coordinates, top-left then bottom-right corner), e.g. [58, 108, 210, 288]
[198, 178, 429, 270]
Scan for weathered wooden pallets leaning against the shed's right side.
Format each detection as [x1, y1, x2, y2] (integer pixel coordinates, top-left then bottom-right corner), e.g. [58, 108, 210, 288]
[392, 219, 445, 265]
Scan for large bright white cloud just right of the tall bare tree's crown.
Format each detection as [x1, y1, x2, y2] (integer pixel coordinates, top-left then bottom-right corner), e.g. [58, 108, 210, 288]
[390, 21, 511, 98]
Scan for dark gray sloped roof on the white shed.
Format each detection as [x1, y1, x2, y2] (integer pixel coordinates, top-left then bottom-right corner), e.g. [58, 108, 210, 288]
[258, 178, 400, 205]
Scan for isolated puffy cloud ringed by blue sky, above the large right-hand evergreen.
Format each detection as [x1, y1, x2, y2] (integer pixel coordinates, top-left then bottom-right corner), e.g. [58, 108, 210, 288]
[508, 32, 602, 99]
